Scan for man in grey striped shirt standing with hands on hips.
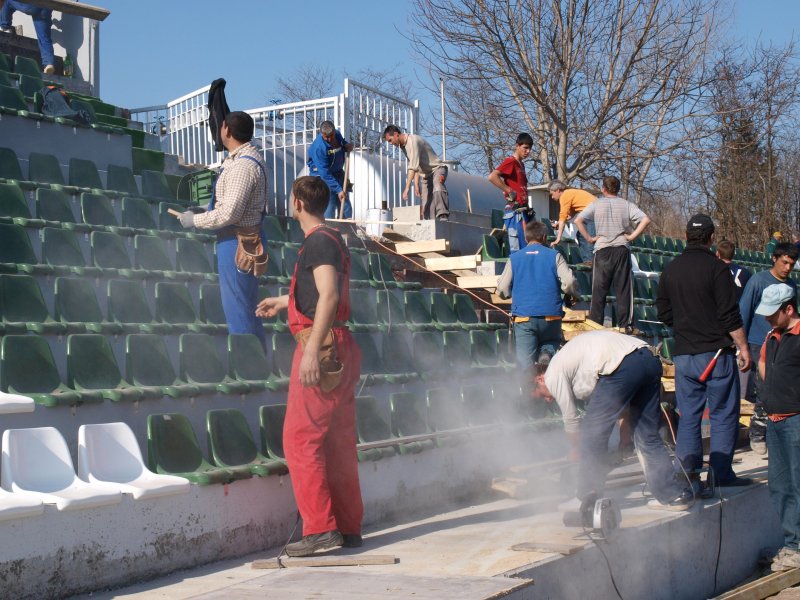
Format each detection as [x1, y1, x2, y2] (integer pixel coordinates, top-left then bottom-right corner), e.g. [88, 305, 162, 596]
[575, 175, 650, 333]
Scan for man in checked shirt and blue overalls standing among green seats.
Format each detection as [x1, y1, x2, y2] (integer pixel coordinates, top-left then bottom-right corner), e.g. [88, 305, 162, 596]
[180, 111, 267, 344]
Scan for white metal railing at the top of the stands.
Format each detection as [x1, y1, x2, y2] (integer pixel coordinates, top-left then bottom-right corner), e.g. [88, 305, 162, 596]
[147, 79, 419, 215]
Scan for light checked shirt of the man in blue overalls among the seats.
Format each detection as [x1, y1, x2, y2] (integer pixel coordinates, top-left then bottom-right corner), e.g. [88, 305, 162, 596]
[194, 142, 267, 229]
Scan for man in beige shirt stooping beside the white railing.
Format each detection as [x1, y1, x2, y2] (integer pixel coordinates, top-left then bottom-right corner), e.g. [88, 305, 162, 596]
[383, 125, 450, 221]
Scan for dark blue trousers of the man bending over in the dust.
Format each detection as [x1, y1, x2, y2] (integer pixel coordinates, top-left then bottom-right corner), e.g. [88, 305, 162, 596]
[577, 348, 684, 503]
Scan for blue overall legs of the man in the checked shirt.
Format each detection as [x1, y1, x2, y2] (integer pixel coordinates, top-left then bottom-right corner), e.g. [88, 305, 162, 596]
[217, 237, 267, 347]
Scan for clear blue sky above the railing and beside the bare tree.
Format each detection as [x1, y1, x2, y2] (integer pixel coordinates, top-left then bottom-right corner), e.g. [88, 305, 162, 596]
[97, 0, 800, 119]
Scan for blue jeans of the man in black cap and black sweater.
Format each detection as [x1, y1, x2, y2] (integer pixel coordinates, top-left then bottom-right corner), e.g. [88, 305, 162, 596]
[674, 351, 740, 483]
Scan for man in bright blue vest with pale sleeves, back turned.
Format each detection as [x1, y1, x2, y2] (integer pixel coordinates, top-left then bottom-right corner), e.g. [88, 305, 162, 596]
[497, 221, 578, 370]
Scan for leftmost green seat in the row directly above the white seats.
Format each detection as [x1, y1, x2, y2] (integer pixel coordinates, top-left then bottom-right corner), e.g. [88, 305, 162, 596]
[0, 335, 85, 406]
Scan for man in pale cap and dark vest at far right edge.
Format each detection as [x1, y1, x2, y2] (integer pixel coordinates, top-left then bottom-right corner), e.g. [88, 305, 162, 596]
[756, 283, 800, 571]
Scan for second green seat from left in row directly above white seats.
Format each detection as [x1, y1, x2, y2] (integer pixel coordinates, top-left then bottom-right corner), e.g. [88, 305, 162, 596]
[67, 333, 152, 402]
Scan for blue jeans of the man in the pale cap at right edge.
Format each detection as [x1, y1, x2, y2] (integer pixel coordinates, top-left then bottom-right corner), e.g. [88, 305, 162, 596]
[767, 415, 800, 550]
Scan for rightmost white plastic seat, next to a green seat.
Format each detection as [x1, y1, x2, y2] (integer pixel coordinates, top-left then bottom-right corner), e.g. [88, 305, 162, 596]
[78, 423, 189, 500]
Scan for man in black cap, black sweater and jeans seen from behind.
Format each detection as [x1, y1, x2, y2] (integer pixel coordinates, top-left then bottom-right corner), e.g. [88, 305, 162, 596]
[656, 214, 752, 492]
